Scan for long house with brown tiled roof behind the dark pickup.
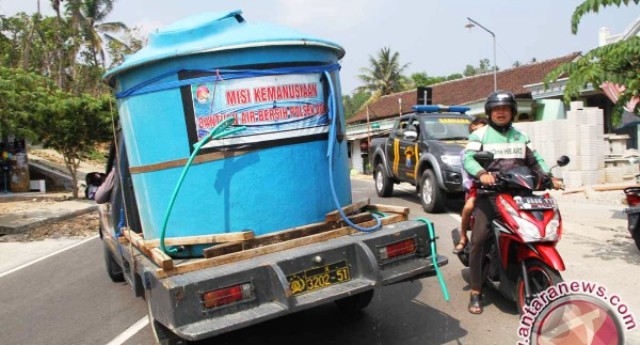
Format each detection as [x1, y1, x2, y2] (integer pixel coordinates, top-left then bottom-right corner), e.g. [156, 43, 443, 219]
[347, 52, 612, 172]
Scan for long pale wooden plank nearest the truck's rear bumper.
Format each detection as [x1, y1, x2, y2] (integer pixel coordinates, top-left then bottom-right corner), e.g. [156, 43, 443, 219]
[156, 214, 403, 279]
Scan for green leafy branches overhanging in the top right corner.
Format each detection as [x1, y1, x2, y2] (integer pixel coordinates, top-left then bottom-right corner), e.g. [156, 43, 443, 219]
[544, 0, 640, 113]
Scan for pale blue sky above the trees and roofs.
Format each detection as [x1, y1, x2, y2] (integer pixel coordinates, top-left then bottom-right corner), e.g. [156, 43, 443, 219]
[0, 0, 640, 94]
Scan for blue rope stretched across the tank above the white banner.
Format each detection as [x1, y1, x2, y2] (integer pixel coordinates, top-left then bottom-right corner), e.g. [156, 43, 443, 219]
[116, 63, 340, 99]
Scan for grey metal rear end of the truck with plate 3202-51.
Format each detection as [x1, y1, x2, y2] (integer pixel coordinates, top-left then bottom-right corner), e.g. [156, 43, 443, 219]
[139, 221, 448, 340]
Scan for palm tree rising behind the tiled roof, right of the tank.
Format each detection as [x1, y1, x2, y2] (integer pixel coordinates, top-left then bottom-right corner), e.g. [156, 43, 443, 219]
[357, 47, 409, 97]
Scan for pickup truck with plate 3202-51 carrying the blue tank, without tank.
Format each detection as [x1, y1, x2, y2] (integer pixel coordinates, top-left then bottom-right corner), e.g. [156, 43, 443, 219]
[99, 131, 447, 344]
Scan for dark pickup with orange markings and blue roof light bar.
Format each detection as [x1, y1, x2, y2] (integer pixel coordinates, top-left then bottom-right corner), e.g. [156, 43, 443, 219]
[369, 105, 471, 213]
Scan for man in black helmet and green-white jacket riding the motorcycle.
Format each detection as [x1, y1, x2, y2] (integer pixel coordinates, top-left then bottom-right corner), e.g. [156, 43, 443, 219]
[463, 91, 562, 314]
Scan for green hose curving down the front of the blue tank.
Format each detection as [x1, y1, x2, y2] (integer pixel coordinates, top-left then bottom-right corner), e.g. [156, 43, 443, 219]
[160, 117, 246, 254]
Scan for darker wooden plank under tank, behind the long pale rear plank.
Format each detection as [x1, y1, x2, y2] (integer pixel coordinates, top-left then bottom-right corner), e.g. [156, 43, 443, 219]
[203, 212, 373, 258]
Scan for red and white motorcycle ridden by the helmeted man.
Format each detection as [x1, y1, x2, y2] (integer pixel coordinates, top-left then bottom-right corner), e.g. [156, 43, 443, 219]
[452, 152, 569, 314]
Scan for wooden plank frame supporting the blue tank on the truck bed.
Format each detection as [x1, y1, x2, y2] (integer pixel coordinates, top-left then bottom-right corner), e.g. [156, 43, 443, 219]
[123, 200, 409, 278]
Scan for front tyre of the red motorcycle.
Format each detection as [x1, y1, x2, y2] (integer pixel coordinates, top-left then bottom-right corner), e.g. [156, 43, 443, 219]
[516, 259, 564, 316]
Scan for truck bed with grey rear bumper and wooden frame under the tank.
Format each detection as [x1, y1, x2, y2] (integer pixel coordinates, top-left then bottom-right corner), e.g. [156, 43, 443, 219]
[102, 200, 447, 340]
